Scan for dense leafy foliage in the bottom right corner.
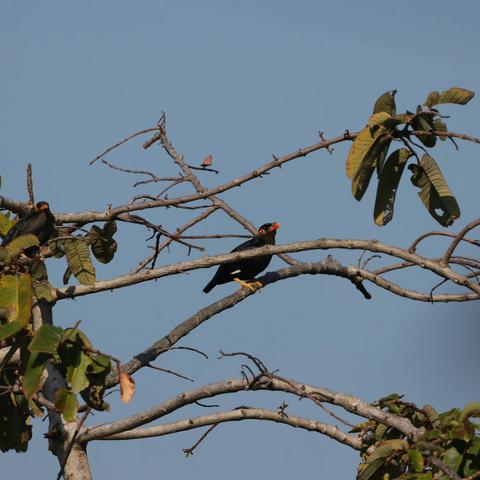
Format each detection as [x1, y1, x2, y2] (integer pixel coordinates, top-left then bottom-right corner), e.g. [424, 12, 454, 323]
[352, 394, 480, 480]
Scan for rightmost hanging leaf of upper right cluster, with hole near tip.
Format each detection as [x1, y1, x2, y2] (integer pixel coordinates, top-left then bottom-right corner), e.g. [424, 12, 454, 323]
[408, 154, 460, 227]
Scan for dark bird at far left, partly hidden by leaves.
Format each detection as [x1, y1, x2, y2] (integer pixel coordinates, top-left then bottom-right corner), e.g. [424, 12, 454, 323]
[2, 202, 55, 247]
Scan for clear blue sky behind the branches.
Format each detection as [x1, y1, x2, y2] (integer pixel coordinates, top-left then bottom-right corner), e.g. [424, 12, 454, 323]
[0, 0, 480, 480]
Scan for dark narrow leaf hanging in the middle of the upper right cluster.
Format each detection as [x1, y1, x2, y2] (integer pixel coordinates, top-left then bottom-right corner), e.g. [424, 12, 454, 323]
[373, 148, 412, 225]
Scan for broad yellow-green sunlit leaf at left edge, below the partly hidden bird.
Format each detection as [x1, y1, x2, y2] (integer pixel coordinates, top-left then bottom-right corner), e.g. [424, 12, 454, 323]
[0, 273, 32, 326]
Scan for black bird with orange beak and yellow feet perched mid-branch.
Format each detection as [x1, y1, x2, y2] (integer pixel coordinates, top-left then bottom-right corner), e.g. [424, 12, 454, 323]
[203, 222, 280, 293]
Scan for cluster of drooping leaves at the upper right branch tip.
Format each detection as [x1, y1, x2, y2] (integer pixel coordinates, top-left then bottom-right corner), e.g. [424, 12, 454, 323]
[346, 87, 474, 226]
